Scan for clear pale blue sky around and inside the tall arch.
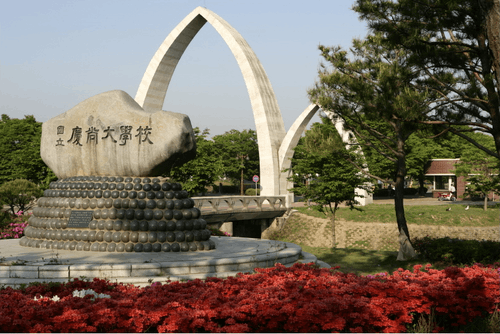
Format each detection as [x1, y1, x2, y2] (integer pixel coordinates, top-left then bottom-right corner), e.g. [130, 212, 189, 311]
[0, 0, 368, 136]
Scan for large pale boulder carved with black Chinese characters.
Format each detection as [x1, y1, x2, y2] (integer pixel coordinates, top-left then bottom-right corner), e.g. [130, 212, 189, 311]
[40, 90, 196, 179]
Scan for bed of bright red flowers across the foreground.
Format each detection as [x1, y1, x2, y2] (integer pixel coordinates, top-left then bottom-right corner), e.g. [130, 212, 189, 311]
[0, 264, 500, 332]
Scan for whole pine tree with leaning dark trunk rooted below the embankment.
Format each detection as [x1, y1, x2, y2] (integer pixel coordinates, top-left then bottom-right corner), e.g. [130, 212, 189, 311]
[308, 35, 432, 260]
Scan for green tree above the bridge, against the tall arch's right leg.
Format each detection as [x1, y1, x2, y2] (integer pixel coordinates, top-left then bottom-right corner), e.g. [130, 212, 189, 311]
[213, 129, 259, 193]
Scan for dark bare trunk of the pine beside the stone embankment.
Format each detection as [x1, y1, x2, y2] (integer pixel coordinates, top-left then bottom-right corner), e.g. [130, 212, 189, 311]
[394, 149, 417, 261]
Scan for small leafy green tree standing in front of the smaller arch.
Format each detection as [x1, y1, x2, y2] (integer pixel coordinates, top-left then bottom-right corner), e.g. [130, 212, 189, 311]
[290, 118, 368, 220]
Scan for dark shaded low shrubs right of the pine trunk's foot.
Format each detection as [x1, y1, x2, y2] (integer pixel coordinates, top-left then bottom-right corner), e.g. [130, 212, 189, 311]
[413, 236, 500, 265]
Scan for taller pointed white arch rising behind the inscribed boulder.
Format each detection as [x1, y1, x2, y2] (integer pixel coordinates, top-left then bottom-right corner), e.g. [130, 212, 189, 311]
[135, 7, 286, 195]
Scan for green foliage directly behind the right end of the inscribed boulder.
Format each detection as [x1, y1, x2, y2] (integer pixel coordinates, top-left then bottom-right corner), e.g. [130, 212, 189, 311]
[169, 127, 223, 194]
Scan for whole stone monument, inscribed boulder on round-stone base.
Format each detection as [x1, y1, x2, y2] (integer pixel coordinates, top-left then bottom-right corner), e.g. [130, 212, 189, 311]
[20, 91, 215, 252]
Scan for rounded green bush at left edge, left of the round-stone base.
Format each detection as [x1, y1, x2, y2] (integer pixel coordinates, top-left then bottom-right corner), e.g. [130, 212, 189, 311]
[0, 179, 43, 214]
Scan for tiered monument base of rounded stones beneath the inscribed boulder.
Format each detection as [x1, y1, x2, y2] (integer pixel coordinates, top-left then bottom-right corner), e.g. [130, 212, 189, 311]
[20, 176, 215, 252]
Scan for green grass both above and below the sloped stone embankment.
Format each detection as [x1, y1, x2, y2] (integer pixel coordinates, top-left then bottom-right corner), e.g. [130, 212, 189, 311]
[279, 204, 500, 275]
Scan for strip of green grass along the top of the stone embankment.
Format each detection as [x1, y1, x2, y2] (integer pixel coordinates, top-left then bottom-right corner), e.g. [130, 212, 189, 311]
[296, 204, 500, 227]
